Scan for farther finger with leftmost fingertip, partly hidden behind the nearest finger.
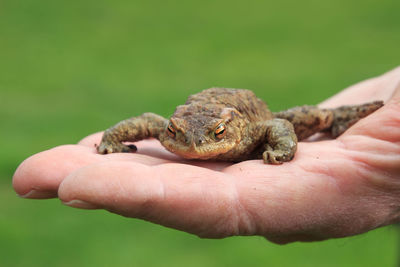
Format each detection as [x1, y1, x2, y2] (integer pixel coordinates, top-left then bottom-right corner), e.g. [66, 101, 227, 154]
[13, 145, 173, 198]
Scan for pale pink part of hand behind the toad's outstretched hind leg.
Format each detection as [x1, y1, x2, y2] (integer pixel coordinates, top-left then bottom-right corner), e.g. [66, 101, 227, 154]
[320, 67, 400, 108]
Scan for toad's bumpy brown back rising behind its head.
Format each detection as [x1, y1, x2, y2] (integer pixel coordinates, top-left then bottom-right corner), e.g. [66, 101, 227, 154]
[185, 87, 273, 121]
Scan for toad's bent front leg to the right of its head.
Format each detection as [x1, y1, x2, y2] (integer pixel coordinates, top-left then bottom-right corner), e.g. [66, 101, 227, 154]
[263, 119, 297, 164]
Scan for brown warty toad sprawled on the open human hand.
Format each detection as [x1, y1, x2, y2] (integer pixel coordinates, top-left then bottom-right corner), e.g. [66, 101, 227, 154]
[97, 88, 383, 164]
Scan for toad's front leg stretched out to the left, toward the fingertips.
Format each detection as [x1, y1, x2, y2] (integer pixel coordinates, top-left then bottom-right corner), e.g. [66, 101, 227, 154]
[97, 113, 168, 154]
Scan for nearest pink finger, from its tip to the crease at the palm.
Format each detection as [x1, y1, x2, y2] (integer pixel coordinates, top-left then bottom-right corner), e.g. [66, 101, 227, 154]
[58, 162, 247, 237]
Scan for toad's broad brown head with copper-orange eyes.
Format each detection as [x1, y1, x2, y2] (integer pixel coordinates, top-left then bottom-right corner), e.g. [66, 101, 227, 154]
[159, 105, 244, 159]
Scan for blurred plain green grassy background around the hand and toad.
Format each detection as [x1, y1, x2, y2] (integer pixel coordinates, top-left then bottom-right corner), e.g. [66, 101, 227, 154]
[0, 0, 400, 266]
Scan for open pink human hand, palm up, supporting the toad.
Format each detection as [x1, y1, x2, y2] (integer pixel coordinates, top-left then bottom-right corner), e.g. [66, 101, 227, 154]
[13, 67, 400, 244]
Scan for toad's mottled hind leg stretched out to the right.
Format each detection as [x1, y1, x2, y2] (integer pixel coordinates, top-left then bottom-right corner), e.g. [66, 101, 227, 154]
[273, 101, 383, 140]
